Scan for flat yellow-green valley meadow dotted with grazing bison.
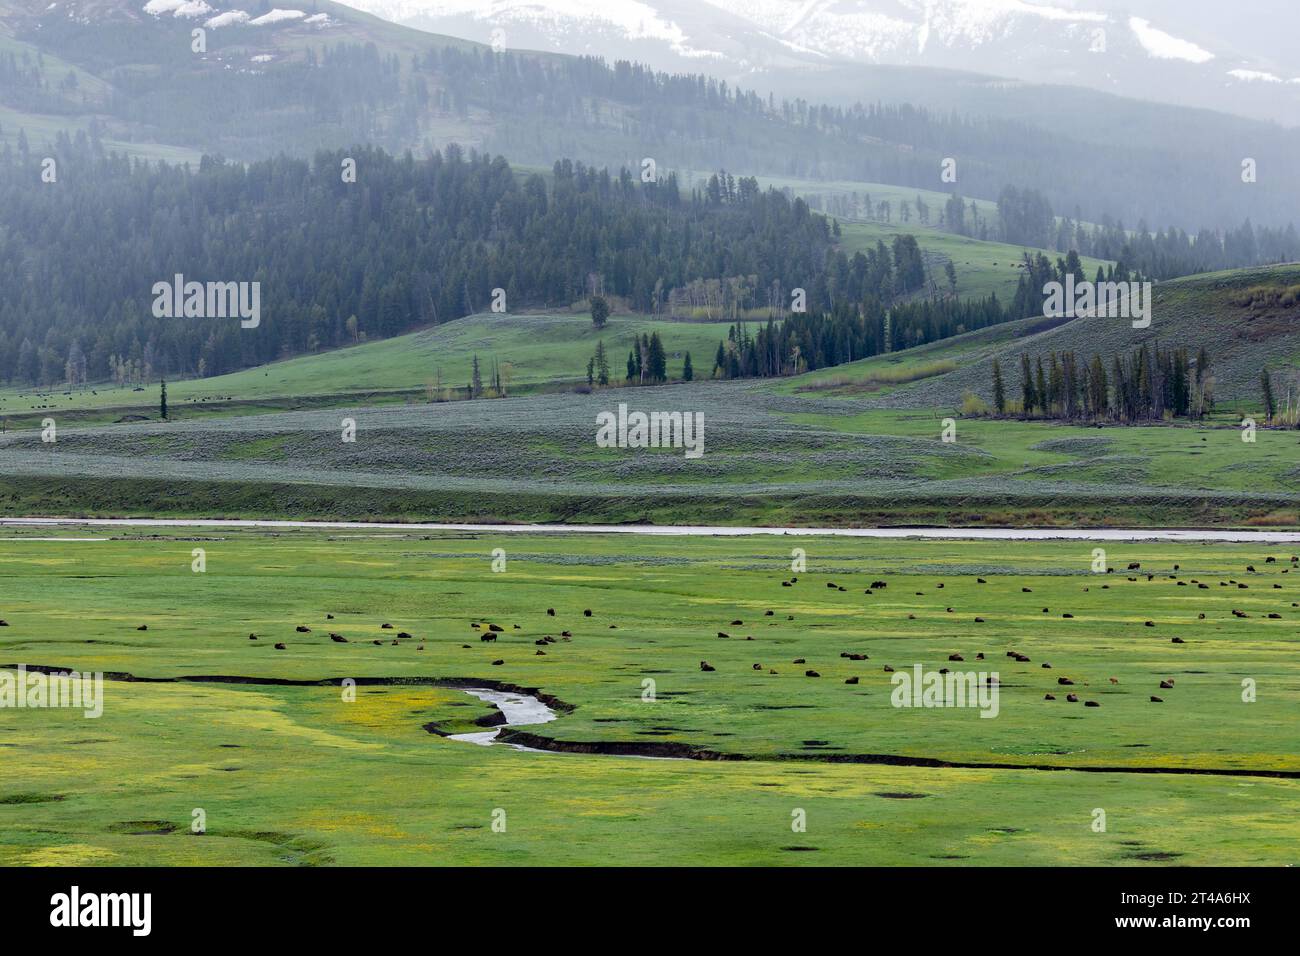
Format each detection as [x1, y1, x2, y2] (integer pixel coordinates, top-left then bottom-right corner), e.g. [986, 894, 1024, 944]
[0, 527, 1300, 865]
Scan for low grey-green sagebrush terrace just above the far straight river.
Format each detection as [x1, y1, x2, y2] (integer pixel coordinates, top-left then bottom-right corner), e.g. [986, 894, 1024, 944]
[0, 382, 1300, 527]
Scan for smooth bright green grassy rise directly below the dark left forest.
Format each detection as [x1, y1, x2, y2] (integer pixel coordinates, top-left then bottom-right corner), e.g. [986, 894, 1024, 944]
[0, 313, 728, 420]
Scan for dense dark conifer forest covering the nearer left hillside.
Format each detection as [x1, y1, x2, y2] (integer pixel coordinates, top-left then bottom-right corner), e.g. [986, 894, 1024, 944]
[0, 143, 842, 385]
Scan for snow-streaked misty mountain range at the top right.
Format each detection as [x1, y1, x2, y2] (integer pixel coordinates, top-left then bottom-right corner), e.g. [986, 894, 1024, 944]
[330, 0, 1300, 125]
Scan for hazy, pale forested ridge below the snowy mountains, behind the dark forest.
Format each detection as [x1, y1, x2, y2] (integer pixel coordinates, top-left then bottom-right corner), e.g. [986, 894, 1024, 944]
[0, 0, 1300, 231]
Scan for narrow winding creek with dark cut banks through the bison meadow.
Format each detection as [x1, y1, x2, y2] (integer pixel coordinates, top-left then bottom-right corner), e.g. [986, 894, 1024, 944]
[10, 663, 1300, 779]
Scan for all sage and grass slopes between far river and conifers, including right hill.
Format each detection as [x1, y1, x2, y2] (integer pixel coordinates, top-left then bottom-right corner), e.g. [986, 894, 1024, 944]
[0, 267, 1300, 527]
